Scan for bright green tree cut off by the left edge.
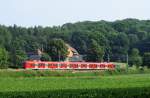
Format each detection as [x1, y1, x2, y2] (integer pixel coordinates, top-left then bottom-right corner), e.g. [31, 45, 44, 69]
[0, 48, 8, 68]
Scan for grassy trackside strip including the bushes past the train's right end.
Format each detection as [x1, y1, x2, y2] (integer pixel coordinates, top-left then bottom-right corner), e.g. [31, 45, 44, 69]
[0, 68, 150, 78]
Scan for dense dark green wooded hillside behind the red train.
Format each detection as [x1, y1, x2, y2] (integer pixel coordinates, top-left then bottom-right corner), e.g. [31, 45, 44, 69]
[0, 19, 150, 68]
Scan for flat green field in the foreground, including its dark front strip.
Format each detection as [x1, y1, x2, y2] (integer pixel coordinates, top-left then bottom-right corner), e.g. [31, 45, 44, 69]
[0, 74, 150, 98]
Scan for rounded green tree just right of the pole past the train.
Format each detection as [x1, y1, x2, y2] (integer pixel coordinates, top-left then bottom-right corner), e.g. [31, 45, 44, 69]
[129, 48, 143, 67]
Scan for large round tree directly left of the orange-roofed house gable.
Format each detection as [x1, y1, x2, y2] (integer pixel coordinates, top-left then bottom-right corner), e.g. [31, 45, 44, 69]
[45, 39, 68, 61]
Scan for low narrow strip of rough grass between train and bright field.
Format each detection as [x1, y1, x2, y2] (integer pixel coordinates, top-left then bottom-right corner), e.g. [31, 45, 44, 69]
[0, 69, 150, 77]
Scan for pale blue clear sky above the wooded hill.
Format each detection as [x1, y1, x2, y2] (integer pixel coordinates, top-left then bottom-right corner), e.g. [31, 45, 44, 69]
[0, 0, 150, 27]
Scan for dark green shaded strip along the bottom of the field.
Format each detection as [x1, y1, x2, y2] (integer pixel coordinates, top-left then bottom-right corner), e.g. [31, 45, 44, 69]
[0, 87, 150, 98]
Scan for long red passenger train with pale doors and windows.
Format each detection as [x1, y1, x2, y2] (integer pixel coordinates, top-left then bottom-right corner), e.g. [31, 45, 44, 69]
[24, 61, 115, 70]
